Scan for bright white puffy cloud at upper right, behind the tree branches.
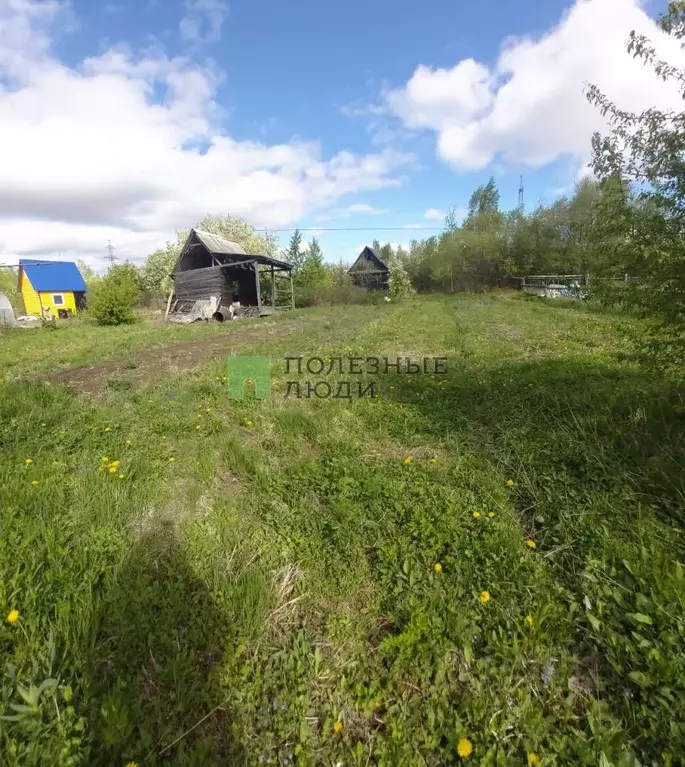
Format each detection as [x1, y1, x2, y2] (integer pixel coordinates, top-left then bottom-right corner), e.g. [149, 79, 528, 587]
[384, 0, 685, 170]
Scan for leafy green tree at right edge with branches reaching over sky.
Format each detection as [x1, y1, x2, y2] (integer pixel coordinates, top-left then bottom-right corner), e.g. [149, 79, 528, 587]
[587, 2, 685, 362]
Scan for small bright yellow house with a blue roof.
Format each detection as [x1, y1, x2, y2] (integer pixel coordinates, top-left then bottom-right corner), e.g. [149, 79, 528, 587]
[18, 258, 86, 317]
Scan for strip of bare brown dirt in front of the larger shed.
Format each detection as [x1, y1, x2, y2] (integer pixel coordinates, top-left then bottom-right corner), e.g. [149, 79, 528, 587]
[42, 314, 318, 398]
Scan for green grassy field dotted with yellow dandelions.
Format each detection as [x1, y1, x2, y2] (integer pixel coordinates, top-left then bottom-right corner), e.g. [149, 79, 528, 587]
[0, 295, 685, 767]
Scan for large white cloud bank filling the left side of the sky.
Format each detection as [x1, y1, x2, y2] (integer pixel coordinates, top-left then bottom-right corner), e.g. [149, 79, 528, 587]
[0, 0, 413, 270]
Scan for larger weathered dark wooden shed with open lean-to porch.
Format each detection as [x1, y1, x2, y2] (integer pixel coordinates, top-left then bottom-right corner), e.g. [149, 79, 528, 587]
[167, 229, 295, 322]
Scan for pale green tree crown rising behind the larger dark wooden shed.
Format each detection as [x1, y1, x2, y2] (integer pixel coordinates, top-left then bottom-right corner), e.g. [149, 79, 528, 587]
[140, 215, 278, 295]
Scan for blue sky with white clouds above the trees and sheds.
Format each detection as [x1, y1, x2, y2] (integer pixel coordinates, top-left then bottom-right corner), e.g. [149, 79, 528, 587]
[0, 0, 682, 266]
